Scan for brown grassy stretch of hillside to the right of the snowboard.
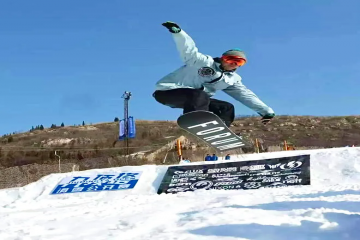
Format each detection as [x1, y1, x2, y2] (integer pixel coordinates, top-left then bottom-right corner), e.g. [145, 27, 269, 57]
[233, 116, 360, 148]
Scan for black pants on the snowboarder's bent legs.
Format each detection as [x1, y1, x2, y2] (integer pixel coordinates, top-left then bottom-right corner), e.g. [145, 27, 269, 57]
[153, 88, 235, 127]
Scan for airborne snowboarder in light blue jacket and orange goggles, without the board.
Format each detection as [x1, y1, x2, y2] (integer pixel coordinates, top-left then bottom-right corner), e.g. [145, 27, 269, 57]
[153, 22, 275, 127]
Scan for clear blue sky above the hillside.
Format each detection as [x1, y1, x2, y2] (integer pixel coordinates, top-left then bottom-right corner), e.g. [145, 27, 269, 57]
[0, 0, 360, 134]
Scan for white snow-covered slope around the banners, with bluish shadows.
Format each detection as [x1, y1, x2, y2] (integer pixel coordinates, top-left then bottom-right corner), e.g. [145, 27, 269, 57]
[0, 147, 360, 240]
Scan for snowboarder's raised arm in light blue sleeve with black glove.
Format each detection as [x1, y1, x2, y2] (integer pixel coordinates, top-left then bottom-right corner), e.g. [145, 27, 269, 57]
[162, 22, 214, 66]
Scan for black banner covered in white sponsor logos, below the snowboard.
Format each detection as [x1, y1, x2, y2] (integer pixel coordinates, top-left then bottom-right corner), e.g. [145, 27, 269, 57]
[157, 155, 310, 194]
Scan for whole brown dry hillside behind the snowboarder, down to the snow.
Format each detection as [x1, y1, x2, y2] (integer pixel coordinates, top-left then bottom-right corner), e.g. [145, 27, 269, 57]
[0, 116, 360, 189]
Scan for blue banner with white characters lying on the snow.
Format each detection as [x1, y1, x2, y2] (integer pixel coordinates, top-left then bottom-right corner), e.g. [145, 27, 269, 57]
[50, 171, 142, 195]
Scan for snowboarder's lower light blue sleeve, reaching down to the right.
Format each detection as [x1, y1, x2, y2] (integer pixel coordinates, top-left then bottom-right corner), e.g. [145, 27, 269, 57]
[224, 81, 275, 117]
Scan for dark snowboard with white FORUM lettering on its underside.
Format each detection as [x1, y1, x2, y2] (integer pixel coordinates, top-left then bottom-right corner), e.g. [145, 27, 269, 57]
[177, 110, 250, 152]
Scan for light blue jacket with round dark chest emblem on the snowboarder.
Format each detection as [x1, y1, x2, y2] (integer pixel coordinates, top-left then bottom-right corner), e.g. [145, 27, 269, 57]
[156, 30, 274, 116]
